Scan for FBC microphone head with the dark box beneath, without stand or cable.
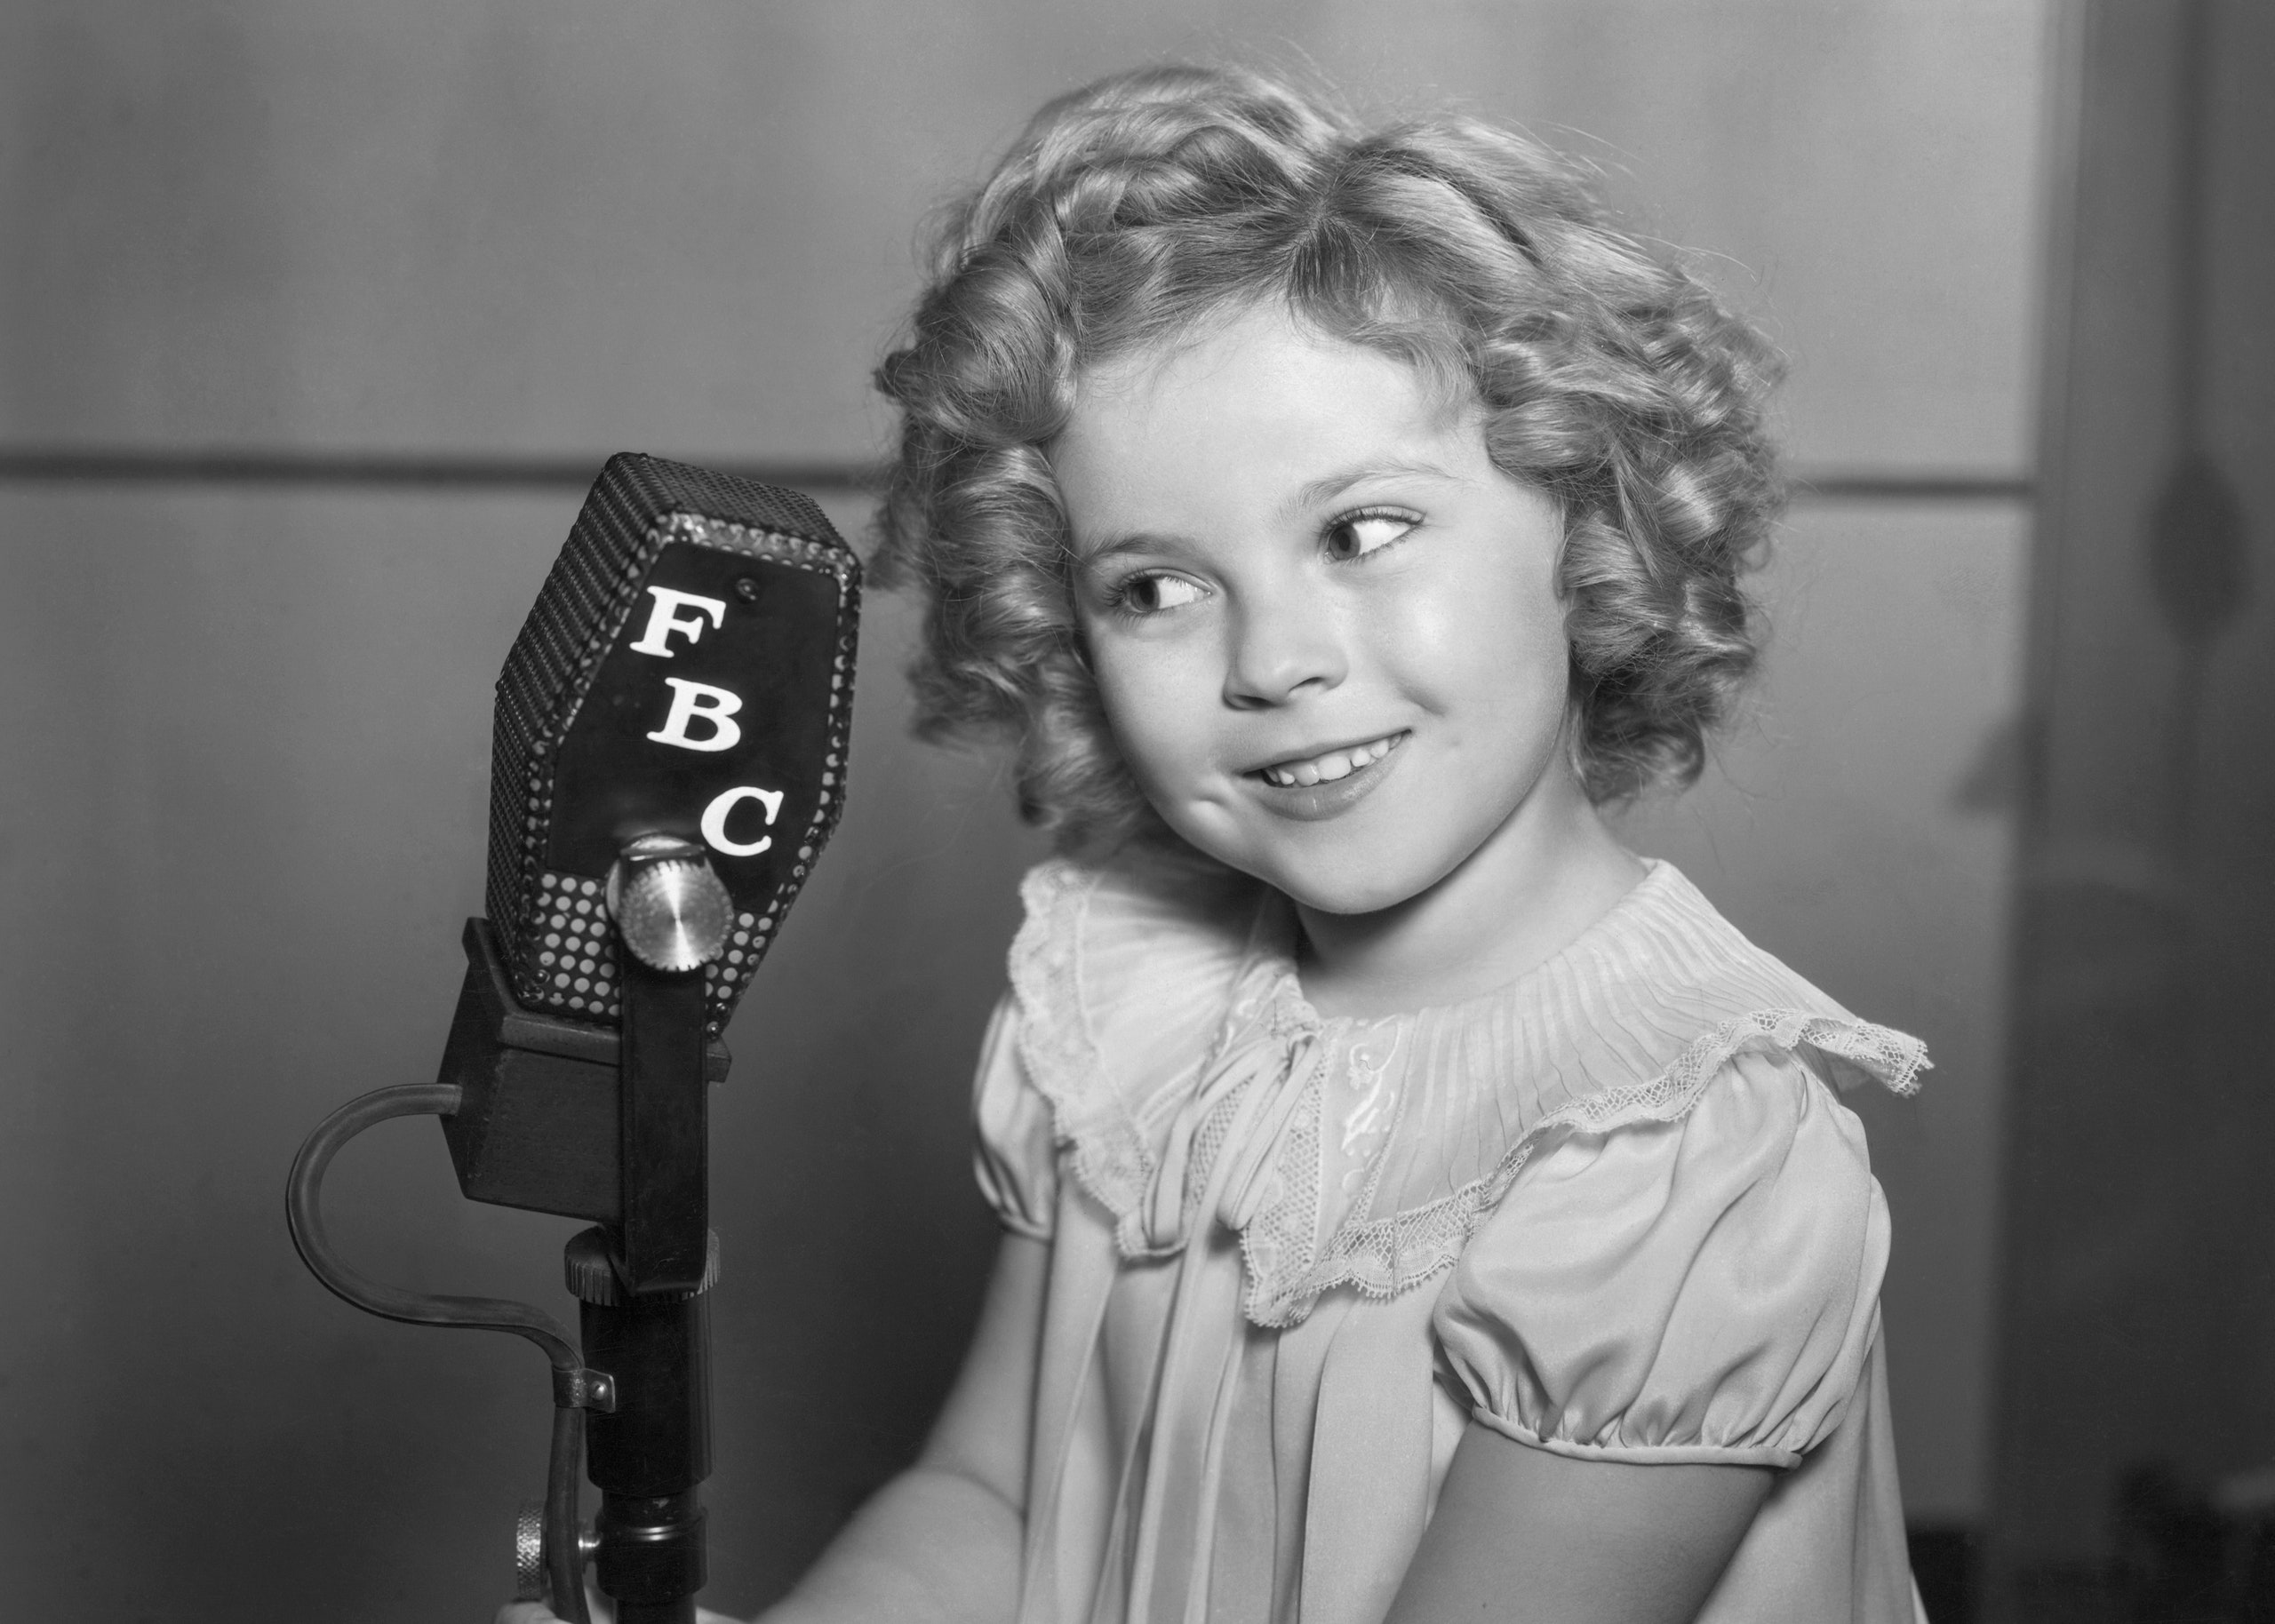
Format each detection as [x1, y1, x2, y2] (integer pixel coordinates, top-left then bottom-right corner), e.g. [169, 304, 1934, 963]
[443, 455, 860, 1292]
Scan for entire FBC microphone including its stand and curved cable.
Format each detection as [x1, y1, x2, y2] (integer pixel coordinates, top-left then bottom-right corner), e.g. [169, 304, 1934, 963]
[287, 455, 860, 1624]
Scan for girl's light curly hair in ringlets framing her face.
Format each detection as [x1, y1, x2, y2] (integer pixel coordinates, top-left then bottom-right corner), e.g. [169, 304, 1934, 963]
[876, 66, 1784, 846]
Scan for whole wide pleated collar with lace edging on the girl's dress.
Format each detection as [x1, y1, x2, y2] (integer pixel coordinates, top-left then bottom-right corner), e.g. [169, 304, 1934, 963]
[1012, 853, 1927, 1326]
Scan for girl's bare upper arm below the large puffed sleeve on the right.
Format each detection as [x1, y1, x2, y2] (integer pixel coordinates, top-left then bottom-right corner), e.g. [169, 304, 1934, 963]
[1388, 1424, 1776, 1624]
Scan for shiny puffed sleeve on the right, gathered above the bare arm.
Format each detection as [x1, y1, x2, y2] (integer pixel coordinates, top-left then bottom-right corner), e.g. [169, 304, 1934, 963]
[1431, 1051, 1888, 1467]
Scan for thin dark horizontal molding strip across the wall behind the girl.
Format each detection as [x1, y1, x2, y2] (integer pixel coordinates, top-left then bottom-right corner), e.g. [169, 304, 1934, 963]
[0, 446, 2036, 503]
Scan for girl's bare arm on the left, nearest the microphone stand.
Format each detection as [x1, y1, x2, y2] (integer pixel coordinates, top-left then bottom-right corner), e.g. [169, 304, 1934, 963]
[764, 1235, 1051, 1624]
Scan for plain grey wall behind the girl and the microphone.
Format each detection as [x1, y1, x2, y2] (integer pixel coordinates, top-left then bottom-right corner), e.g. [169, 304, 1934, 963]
[0, 0, 2045, 1620]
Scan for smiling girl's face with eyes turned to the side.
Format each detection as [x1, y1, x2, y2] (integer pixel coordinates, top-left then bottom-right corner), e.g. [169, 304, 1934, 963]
[1051, 309, 1584, 914]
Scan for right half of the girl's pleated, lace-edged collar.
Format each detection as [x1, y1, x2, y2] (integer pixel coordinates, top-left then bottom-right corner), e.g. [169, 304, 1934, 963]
[1285, 862, 1927, 1301]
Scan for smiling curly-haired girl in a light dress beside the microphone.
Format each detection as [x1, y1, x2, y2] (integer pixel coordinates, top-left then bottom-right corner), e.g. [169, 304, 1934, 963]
[516, 68, 1925, 1624]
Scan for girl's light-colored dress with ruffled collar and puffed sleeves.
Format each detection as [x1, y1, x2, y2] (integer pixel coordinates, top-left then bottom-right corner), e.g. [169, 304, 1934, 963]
[976, 856, 1927, 1624]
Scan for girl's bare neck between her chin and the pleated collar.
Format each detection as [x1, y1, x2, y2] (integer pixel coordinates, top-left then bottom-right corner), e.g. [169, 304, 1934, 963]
[1297, 780, 1642, 1016]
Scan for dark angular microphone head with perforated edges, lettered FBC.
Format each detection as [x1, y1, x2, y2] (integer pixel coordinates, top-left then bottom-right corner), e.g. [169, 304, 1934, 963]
[487, 455, 860, 1037]
